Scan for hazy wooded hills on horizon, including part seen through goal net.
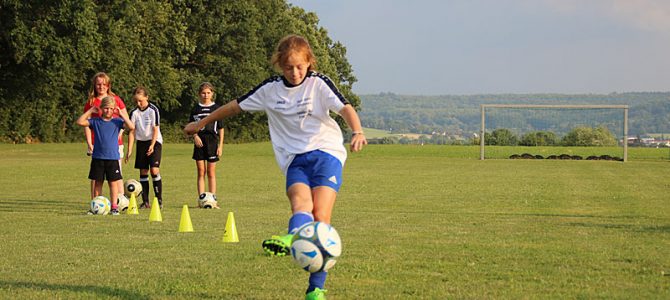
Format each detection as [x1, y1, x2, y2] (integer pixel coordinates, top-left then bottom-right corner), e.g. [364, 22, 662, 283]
[359, 92, 670, 137]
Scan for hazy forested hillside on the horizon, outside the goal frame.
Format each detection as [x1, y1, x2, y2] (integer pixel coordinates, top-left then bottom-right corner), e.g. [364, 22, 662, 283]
[359, 92, 670, 136]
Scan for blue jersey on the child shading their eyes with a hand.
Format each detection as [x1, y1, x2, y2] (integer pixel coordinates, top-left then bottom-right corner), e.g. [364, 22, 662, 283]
[88, 117, 124, 160]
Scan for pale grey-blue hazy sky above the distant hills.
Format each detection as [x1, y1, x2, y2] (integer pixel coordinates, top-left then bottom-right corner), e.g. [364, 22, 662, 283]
[288, 0, 670, 95]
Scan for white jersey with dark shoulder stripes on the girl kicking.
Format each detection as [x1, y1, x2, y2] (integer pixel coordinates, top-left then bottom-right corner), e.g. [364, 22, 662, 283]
[237, 72, 349, 174]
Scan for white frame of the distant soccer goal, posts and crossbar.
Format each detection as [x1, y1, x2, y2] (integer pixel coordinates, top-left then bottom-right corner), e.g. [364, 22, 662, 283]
[479, 104, 628, 162]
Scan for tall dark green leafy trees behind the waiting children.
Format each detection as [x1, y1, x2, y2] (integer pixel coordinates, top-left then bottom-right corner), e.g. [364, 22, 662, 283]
[0, 0, 360, 143]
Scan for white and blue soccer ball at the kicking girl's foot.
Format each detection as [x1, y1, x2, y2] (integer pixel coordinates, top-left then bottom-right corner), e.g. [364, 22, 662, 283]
[291, 222, 342, 273]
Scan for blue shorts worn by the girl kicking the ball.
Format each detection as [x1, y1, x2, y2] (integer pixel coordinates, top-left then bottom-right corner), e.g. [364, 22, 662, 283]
[286, 150, 342, 192]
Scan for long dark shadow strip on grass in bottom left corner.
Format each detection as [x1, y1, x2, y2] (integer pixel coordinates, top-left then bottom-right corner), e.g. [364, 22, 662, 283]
[0, 281, 150, 300]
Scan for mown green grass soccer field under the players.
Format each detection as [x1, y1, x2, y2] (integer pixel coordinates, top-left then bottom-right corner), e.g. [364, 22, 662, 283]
[0, 143, 670, 299]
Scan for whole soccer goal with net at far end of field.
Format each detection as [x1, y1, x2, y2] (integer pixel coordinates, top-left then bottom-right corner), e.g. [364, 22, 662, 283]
[478, 104, 628, 162]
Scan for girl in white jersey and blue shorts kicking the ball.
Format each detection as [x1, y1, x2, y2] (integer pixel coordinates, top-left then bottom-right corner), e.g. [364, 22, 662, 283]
[184, 35, 367, 299]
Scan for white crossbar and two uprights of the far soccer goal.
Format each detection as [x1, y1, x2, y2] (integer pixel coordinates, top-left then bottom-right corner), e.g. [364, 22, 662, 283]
[479, 104, 628, 162]
